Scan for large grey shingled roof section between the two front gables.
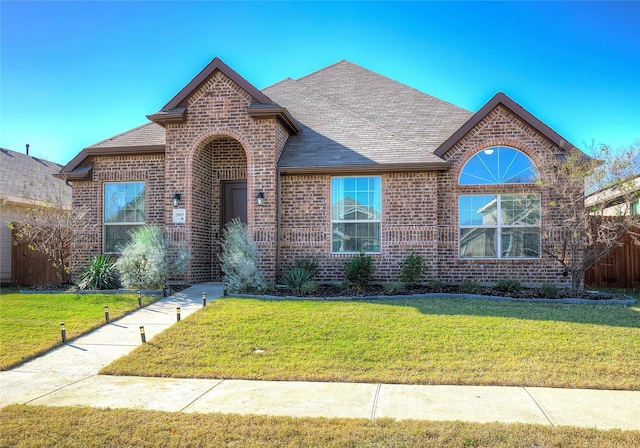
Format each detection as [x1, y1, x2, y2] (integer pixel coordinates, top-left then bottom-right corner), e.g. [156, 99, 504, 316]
[264, 61, 472, 172]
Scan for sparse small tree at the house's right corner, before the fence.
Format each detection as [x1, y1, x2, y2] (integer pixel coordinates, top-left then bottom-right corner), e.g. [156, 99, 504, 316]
[539, 144, 640, 289]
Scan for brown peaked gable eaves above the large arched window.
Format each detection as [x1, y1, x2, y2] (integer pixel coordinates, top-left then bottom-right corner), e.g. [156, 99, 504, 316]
[434, 92, 574, 157]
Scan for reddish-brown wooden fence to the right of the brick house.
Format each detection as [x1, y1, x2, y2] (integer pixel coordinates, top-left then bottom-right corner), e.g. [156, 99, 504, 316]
[584, 226, 640, 288]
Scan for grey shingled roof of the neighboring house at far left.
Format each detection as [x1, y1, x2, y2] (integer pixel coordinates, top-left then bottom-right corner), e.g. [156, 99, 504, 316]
[0, 148, 71, 205]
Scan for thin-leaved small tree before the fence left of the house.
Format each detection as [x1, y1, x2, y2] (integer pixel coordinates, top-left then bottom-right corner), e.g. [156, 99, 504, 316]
[6, 164, 88, 283]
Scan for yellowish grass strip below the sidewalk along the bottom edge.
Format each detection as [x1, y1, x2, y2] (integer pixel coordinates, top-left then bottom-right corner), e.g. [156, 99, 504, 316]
[0, 405, 640, 448]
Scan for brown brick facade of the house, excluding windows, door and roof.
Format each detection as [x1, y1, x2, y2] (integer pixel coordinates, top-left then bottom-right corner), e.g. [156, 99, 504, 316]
[67, 59, 568, 283]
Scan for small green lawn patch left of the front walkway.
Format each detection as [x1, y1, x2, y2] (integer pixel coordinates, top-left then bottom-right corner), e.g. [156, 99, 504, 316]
[0, 288, 154, 370]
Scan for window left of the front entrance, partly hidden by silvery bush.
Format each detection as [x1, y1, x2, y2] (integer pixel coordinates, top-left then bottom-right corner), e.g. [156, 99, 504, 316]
[102, 182, 145, 254]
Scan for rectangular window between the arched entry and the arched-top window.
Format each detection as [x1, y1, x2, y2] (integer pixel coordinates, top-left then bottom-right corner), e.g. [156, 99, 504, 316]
[331, 176, 382, 253]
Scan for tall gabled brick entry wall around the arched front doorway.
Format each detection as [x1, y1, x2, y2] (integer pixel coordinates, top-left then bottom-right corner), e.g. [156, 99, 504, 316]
[165, 72, 287, 283]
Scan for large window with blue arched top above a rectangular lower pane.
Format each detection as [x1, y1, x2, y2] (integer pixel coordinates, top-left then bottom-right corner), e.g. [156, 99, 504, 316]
[458, 147, 540, 259]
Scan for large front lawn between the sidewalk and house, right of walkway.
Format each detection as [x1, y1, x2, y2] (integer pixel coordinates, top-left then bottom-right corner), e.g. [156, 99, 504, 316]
[102, 299, 640, 390]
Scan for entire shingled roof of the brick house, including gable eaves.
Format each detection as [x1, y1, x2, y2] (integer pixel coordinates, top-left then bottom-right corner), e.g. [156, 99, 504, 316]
[61, 58, 571, 180]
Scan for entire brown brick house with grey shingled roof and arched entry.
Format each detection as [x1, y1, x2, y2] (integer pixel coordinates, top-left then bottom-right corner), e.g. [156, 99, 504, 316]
[61, 58, 573, 283]
